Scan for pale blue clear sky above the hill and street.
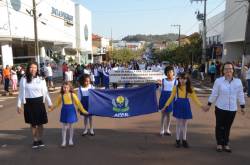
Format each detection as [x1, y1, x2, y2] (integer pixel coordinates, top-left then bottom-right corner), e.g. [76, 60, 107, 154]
[74, 0, 226, 39]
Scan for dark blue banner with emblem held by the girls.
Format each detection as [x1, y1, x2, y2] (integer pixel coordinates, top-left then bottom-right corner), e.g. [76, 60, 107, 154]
[89, 84, 158, 118]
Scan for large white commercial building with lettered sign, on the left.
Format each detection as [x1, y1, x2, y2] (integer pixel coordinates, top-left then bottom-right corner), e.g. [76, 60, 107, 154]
[0, 0, 93, 66]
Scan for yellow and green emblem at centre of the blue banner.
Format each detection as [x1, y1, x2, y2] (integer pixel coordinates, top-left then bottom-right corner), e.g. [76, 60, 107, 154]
[112, 96, 129, 113]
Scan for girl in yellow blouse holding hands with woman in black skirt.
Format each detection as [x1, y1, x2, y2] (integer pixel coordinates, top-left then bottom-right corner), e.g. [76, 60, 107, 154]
[50, 82, 88, 147]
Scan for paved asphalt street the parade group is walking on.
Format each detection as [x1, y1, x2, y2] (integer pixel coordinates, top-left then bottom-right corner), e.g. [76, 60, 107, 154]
[0, 83, 250, 165]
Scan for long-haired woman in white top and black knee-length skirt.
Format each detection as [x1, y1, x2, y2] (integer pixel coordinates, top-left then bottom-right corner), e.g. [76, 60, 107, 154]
[17, 62, 52, 149]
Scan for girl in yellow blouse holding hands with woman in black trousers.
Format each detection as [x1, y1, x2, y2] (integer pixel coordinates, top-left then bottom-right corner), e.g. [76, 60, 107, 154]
[162, 73, 205, 148]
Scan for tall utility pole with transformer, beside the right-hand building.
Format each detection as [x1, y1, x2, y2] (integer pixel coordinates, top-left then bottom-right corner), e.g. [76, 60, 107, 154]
[190, 0, 207, 63]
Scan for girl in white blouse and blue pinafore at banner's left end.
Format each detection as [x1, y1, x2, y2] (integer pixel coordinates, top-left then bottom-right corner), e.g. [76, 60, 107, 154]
[78, 74, 95, 136]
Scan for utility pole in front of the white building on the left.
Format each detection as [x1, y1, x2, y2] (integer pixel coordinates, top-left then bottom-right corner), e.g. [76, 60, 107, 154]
[32, 0, 40, 69]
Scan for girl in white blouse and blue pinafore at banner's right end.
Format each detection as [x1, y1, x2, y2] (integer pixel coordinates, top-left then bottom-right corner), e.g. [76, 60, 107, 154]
[159, 66, 177, 136]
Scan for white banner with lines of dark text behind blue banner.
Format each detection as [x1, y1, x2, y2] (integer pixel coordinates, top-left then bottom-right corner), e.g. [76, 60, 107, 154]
[109, 70, 163, 84]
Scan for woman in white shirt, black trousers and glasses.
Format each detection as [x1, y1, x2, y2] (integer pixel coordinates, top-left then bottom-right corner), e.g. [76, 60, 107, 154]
[207, 62, 245, 152]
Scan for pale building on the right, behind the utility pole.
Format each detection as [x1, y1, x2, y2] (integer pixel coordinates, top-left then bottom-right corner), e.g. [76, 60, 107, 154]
[201, 0, 250, 63]
